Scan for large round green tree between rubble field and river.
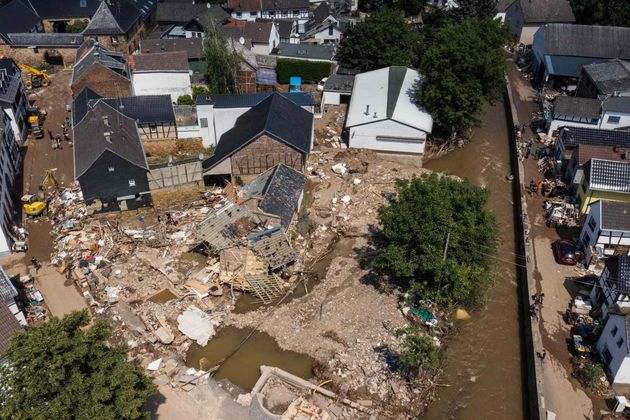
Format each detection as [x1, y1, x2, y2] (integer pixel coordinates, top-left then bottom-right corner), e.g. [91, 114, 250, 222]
[372, 174, 498, 306]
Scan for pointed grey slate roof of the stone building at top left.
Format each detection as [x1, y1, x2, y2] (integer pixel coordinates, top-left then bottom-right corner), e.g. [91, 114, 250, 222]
[83, 0, 143, 35]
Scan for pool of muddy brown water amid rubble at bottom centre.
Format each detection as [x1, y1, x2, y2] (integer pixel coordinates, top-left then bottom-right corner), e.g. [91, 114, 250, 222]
[186, 326, 315, 391]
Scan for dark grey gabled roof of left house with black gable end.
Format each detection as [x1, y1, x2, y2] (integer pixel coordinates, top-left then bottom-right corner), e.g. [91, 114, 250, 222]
[73, 101, 149, 179]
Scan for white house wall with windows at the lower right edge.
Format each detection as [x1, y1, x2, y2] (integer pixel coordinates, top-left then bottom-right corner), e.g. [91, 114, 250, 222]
[596, 315, 630, 384]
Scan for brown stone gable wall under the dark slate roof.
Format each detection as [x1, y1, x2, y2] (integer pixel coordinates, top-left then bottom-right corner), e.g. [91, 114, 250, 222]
[232, 135, 304, 175]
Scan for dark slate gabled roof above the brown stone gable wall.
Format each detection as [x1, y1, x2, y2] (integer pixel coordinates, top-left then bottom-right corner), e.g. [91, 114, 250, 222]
[203, 93, 313, 169]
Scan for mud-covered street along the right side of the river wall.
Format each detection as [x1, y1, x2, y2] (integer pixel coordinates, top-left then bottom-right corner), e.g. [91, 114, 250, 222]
[509, 65, 599, 420]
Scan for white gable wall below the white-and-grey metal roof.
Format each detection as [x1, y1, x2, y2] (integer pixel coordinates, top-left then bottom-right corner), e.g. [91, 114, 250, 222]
[349, 120, 427, 155]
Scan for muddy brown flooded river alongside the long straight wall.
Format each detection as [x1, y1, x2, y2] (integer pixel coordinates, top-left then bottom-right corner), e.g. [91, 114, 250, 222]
[425, 104, 526, 420]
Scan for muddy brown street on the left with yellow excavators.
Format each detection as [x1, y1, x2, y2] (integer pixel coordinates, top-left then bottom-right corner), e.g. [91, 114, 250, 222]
[0, 70, 86, 316]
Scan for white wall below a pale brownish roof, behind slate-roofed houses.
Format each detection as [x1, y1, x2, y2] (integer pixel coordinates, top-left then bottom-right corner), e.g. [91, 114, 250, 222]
[131, 72, 192, 102]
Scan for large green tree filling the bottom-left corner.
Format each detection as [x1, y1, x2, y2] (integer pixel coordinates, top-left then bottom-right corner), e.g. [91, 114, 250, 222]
[0, 310, 156, 419]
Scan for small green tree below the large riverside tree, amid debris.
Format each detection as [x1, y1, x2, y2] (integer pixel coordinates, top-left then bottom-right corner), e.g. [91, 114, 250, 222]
[396, 324, 442, 376]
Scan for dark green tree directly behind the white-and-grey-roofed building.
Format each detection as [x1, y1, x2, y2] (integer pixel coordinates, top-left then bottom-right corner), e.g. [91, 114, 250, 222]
[337, 8, 422, 71]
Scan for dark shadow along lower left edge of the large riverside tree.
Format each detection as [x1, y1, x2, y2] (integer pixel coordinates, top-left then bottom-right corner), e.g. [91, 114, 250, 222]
[354, 225, 409, 294]
